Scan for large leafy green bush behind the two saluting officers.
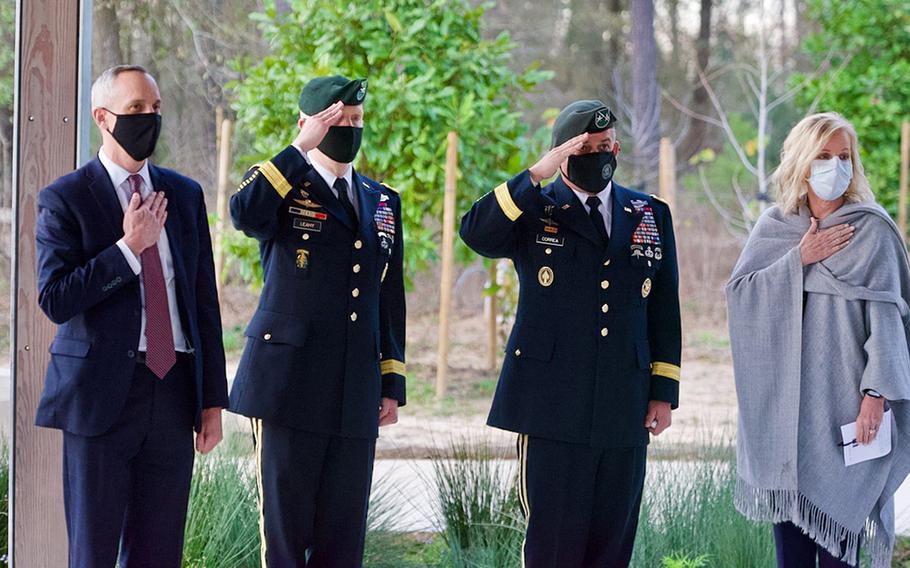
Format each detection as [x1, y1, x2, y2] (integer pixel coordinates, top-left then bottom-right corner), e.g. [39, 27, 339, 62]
[228, 0, 550, 282]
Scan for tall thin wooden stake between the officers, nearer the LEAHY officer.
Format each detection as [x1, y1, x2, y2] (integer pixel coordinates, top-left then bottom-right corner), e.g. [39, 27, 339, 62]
[436, 132, 458, 400]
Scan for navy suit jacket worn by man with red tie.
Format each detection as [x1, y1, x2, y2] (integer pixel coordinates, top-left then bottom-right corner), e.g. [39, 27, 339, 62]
[36, 157, 228, 436]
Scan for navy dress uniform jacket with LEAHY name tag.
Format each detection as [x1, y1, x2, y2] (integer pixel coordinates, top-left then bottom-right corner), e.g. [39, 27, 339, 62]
[231, 146, 405, 438]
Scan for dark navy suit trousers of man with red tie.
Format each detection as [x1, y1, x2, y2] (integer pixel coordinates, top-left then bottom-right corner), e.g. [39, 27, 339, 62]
[63, 354, 195, 568]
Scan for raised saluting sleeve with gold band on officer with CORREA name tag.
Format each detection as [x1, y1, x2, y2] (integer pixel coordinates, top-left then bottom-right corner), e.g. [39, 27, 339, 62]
[461, 170, 540, 258]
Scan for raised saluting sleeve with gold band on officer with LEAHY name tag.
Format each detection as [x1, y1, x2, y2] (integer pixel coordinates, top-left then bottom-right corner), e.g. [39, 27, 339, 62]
[231, 146, 312, 241]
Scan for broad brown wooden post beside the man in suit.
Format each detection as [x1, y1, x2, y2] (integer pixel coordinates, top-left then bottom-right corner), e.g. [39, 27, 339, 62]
[9, 0, 81, 568]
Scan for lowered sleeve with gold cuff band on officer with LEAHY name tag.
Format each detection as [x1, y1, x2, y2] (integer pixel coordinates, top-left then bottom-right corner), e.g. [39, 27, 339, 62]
[379, 193, 407, 406]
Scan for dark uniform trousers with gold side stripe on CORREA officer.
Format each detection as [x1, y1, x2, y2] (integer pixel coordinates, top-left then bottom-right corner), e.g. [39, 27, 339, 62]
[518, 434, 647, 568]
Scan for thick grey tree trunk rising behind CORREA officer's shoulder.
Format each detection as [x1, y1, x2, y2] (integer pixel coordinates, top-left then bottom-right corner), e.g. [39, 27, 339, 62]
[630, 0, 660, 181]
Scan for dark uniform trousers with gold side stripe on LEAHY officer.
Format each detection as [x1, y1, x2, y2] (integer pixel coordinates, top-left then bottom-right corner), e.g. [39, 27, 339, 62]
[252, 418, 376, 568]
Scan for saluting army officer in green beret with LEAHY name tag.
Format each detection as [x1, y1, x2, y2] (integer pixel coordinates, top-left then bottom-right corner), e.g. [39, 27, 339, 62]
[230, 76, 405, 568]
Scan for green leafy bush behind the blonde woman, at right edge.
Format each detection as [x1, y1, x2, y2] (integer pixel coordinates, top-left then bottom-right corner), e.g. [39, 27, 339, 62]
[793, 0, 910, 214]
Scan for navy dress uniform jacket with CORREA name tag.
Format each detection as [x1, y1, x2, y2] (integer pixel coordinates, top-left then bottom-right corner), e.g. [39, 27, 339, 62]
[461, 171, 681, 447]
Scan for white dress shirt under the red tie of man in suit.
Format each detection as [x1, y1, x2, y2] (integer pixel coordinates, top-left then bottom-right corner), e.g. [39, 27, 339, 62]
[98, 146, 189, 352]
